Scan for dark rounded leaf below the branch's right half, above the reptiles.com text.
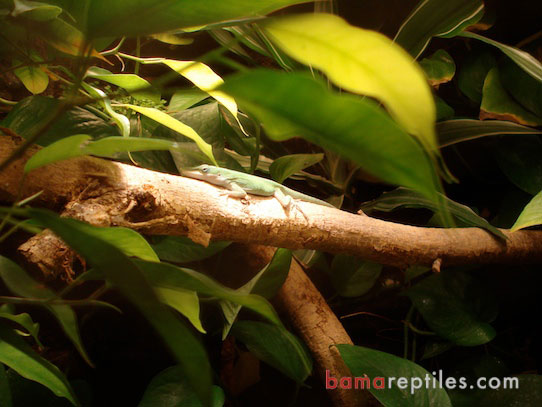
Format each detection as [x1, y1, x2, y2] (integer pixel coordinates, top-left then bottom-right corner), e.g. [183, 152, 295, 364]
[406, 270, 497, 346]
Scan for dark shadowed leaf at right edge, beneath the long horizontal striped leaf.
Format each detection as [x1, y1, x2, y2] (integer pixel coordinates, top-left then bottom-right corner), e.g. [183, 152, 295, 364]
[493, 136, 542, 196]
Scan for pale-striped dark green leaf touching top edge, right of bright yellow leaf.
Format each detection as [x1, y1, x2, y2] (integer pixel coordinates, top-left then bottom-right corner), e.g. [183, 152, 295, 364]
[395, 0, 484, 59]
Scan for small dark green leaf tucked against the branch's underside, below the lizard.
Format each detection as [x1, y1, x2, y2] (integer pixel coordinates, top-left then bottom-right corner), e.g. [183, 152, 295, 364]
[151, 236, 230, 263]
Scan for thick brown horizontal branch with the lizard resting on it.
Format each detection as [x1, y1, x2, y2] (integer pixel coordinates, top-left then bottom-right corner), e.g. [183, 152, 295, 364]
[0, 137, 542, 267]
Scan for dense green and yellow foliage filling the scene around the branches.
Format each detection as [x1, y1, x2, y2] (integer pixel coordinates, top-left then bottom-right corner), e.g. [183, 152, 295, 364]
[0, 0, 542, 407]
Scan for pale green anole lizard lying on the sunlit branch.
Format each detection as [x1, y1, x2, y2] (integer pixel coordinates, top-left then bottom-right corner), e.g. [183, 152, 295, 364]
[181, 164, 335, 218]
